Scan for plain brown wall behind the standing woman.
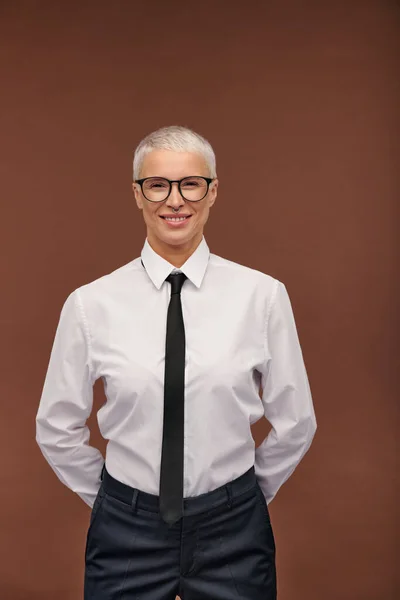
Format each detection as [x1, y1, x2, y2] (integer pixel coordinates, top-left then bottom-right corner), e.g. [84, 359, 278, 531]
[0, 0, 400, 600]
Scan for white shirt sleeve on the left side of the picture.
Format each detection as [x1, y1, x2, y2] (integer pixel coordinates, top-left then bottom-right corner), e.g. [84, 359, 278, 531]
[36, 290, 104, 507]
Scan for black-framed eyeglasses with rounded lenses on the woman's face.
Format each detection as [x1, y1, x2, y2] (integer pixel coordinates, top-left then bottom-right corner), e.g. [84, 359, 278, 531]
[135, 175, 213, 202]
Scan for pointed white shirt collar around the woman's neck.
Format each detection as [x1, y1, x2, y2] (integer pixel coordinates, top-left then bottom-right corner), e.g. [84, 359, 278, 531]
[141, 235, 210, 290]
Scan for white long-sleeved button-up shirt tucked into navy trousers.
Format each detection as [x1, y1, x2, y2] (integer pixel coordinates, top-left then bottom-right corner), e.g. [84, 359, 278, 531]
[36, 236, 316, 506]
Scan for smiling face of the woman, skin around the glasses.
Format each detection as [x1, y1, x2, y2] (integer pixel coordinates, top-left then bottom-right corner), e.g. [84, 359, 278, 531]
[132, 150, 218, 255]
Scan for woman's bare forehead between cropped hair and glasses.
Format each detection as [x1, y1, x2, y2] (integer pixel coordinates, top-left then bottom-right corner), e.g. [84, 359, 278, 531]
[140, 150, 209, 179]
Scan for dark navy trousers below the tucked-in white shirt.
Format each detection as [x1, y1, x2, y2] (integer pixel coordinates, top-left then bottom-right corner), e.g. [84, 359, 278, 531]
[84, 467, 277, 600]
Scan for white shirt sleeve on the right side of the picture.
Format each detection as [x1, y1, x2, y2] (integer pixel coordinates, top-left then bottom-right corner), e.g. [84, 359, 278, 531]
[255, 280, 317, 503]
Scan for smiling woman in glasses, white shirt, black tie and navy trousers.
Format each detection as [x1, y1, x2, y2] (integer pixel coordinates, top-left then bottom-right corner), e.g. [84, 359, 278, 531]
[36, 126, 316, 600]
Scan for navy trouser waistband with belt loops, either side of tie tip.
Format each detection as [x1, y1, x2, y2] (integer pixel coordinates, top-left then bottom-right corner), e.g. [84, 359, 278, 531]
[102, 466, 257, 515]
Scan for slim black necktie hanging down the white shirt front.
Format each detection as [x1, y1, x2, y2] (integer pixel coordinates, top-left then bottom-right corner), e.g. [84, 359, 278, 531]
[142, 262, 187, 525]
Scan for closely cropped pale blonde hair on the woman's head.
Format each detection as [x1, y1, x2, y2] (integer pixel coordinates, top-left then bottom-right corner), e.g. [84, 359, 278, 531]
[133, 125, 217, 180]
